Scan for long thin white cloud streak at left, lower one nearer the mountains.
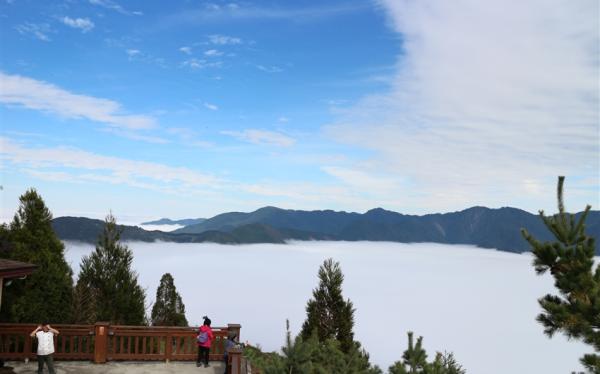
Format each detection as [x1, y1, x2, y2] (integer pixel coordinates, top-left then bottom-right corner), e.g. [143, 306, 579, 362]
[0, 137, 219, 191]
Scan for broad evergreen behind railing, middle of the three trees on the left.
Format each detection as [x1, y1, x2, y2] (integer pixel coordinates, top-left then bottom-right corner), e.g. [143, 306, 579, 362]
[77, 214, 146, 325]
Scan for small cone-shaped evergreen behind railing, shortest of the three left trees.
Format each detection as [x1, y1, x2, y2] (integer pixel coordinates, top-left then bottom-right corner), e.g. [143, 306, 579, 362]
[152, 273, 188, 326]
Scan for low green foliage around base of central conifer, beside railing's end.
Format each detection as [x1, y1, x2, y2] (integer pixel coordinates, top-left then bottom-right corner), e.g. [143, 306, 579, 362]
[244, 318, 381, 374]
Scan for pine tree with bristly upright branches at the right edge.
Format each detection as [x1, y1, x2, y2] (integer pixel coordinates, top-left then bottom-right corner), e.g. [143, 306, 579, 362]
[522, 176, 600, 374]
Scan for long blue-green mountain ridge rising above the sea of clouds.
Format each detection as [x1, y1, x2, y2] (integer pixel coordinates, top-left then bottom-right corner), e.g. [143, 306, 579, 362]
[52, 207, 600, 255]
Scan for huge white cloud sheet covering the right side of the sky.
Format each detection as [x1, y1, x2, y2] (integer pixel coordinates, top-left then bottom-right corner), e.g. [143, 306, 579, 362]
[325, 0, 600, 210]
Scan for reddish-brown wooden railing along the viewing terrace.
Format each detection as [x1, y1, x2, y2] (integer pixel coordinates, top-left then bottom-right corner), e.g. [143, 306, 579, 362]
[0, 322, 241, 366]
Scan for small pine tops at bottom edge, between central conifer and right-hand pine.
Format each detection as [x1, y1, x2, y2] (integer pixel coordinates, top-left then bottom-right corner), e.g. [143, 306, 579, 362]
[389, 332, 466, 374]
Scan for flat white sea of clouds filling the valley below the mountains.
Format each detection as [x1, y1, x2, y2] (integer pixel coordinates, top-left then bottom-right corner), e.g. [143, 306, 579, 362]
[67, 242, 587, 374]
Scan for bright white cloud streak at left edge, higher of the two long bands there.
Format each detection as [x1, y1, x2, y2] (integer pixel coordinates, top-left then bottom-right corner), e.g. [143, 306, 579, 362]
[0, 72, 156, 130]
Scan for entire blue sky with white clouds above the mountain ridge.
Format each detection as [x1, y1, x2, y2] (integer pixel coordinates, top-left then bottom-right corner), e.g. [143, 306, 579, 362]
[0, 0, 600, 222]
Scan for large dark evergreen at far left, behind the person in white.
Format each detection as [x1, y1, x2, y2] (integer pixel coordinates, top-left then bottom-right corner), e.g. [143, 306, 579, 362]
[0, 189, 73, 323]
